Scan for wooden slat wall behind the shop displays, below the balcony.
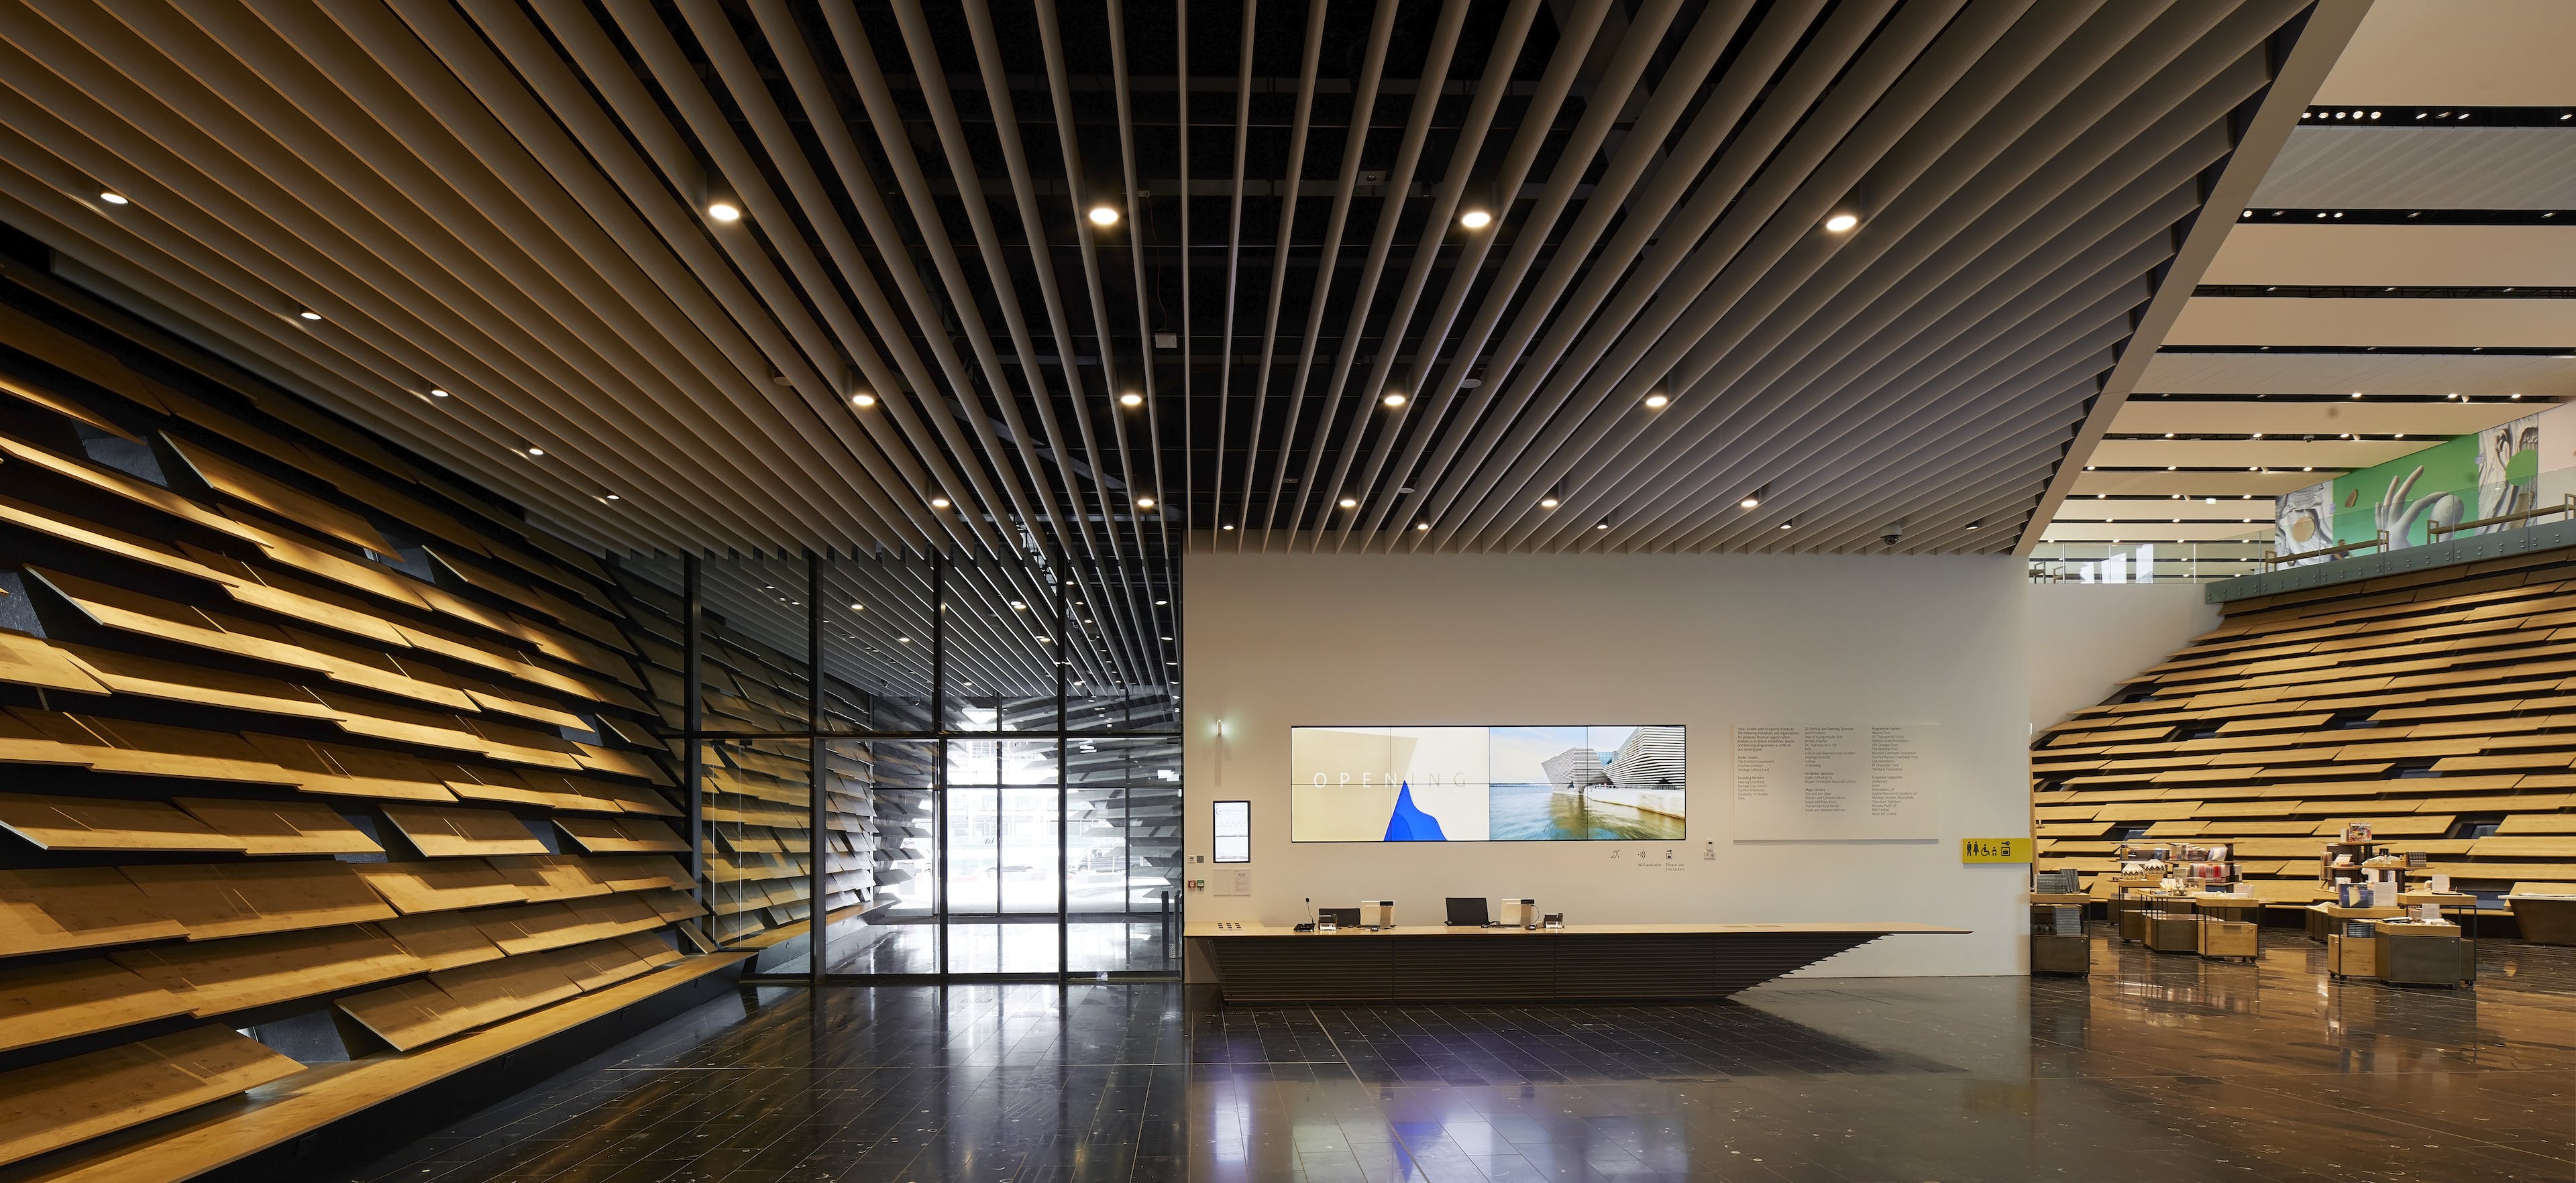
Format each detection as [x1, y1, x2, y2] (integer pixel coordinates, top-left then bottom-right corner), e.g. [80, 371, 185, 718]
[2030, 549, 2576, 907]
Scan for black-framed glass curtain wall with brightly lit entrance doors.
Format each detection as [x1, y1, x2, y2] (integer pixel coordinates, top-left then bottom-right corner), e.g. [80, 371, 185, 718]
[621, 557, 1183, 984]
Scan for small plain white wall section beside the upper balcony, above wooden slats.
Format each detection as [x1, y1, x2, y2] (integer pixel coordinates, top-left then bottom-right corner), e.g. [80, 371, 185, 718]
[2022, 583, 2218, 730]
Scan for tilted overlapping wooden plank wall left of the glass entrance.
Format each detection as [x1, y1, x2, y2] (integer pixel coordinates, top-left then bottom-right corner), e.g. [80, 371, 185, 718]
[0, 286, 706, 1162]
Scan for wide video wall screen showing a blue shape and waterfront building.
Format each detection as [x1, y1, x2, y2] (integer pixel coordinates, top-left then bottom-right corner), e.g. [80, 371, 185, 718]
[1288, 724, 1687, 843]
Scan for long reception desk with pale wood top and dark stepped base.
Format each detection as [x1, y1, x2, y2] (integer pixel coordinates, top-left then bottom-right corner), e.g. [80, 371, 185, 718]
[1183, 920, 1968, 1003]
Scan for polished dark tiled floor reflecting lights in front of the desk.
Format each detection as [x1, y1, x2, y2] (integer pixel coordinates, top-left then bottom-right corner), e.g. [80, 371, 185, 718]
[343, 933, 2576, 1183]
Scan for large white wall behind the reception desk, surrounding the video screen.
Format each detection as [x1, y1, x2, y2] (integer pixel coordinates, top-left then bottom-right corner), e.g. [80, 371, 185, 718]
[1183, 549, 2030, 974]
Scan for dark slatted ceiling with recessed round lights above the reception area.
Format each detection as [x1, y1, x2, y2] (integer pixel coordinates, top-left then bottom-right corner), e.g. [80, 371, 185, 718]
[0, 0, 2306, 561]
